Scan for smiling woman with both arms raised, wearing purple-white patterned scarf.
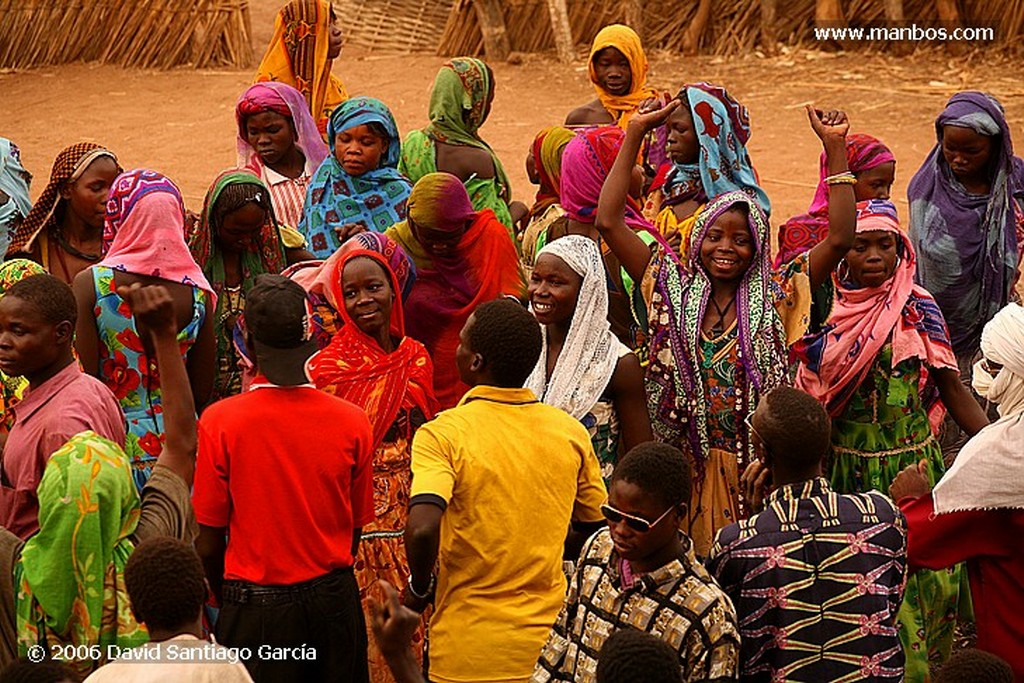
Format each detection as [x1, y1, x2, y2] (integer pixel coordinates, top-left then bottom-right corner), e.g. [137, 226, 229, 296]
[596, 100, 856, 555]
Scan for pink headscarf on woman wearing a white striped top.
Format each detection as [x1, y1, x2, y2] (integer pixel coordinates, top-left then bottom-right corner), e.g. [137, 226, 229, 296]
[234, 81, 328, 177]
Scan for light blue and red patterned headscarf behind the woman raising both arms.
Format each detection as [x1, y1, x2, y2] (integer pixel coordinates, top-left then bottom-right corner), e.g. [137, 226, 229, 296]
[665, 83, 771, 216]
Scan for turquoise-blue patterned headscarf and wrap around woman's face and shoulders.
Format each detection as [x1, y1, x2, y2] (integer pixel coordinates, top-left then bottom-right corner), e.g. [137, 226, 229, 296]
[299, 97, 413, 259]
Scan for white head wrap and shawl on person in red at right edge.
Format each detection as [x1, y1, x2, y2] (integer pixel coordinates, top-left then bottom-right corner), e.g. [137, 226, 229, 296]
[932, 303, 1024, 513]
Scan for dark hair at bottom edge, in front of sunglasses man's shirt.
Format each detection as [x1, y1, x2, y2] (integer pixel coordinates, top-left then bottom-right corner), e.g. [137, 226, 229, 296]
[597, 628, 683, 683]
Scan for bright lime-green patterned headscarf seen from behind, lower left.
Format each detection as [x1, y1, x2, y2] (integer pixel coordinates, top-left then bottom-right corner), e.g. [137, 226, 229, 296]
[14, 431, 148, 670]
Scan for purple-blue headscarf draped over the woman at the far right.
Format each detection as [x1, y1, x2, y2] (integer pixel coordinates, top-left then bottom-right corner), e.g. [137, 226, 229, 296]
[906, 91, 1024, 355]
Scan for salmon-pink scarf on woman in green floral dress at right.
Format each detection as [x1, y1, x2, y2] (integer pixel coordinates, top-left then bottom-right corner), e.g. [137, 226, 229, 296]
[795, 200, 956, 426]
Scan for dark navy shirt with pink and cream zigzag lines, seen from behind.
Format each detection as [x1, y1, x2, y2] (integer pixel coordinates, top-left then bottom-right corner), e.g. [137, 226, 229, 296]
[708, 477, 906, 681]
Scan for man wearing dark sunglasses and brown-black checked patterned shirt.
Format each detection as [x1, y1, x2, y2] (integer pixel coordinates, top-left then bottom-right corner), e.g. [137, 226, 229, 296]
[531, 441, 739, 683]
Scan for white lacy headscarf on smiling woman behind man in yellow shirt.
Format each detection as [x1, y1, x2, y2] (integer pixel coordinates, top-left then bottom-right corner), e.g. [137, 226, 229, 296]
[526, 234, 625, 420]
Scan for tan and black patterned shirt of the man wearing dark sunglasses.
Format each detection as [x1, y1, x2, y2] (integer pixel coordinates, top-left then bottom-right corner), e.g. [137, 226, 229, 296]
[530, 528, 739, 683]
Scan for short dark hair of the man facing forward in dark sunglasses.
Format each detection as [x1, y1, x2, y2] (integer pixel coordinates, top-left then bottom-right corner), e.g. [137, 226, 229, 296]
[611, 441, 693, 508]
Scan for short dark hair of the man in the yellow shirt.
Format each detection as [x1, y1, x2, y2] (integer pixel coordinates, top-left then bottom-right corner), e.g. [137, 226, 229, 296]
[466, 299, 544, 388]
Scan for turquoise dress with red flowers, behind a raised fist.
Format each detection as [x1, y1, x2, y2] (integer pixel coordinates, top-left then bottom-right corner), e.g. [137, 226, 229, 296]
[92, 265, 207, 492]
